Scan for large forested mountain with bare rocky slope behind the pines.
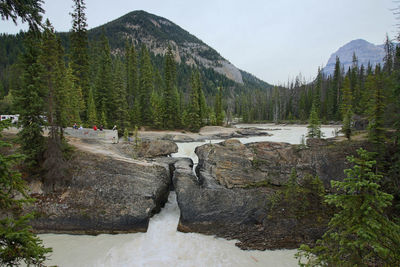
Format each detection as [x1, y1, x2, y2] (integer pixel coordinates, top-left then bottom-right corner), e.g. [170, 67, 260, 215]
[0, 11, 272, 97]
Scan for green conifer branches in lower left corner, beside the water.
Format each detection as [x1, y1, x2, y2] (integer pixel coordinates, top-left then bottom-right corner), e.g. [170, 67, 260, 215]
[0, 121, 51, 266]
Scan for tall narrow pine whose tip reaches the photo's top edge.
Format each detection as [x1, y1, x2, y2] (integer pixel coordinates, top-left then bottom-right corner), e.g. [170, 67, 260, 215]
[70, 0, 90, 110]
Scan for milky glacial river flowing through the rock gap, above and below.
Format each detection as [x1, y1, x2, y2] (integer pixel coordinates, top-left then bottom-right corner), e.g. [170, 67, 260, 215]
[39, 124, 337, 267]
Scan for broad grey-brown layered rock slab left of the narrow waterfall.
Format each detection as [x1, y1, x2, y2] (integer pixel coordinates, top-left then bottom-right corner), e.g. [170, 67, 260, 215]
[30, 152, 171, 234]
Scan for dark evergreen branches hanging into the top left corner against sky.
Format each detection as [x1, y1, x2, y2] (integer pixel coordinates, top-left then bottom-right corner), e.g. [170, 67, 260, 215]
[0, 0, 44, 32]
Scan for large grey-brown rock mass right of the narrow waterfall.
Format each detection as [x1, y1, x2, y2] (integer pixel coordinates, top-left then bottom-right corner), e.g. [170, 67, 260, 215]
[173, 139, 355, 249]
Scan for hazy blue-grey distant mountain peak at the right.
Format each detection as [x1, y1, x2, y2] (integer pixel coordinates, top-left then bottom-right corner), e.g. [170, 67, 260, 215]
[323, 39, 385, 75]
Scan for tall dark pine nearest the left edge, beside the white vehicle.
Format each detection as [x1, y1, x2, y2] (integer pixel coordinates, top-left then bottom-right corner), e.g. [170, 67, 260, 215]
[15, 28, 46, 169]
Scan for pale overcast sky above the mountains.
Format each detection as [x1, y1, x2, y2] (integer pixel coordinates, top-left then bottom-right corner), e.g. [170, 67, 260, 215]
[0, 0, 398, 84]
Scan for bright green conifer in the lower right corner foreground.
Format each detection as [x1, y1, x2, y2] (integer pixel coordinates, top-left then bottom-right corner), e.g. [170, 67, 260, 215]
[298, 149, 400, 266]
